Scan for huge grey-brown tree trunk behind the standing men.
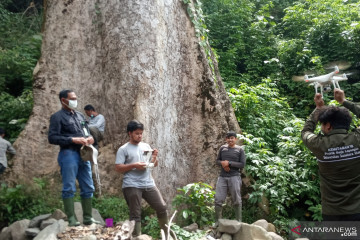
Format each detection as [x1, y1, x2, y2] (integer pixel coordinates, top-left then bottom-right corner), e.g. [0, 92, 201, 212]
[4, 0, 240, 201]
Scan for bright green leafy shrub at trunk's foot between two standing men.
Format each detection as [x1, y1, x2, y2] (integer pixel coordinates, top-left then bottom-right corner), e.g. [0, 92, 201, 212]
[172, 182, 215, 227]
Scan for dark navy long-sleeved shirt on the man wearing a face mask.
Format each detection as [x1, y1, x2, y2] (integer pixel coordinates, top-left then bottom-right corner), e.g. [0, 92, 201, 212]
[48, 108, 89, 150]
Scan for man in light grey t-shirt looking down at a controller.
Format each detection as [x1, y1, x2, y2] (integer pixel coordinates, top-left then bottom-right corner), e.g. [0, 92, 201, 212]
[115, 120, 168, 236]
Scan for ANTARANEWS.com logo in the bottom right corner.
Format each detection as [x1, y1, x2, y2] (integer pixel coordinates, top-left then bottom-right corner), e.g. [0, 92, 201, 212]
[289, 222, 360, 240]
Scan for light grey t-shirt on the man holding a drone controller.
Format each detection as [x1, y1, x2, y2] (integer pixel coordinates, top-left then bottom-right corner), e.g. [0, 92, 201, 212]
[115, 142, 155, 188]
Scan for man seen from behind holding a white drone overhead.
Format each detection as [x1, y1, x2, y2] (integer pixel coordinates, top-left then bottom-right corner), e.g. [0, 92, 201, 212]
[301, 88, 360, 221]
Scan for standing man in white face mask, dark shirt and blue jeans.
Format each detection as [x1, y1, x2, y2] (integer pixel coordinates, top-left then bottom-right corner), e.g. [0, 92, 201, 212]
[48, 90, 100, 226]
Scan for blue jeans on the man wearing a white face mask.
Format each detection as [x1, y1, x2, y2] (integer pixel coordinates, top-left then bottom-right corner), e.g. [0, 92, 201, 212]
[58, 149, 95, 198]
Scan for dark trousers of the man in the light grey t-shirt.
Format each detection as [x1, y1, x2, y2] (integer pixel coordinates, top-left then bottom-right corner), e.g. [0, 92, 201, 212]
[123, 187, 167, 222]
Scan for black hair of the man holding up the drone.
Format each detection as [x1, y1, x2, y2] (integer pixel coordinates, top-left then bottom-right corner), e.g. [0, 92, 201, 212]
[318, 106, 352, 130]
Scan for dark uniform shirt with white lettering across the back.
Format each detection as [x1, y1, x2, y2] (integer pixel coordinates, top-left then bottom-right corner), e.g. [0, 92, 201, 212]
[301, 101, 360, 215]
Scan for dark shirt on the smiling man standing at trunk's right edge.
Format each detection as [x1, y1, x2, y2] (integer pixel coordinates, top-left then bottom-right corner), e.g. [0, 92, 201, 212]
[216, 144, 246, 177]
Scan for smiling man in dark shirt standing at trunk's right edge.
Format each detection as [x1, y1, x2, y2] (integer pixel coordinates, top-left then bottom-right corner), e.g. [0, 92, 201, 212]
[215, 131, 246, 224]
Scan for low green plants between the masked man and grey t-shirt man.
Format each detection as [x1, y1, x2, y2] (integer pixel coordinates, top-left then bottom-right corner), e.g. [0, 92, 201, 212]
[93, 196, 129, 222]
